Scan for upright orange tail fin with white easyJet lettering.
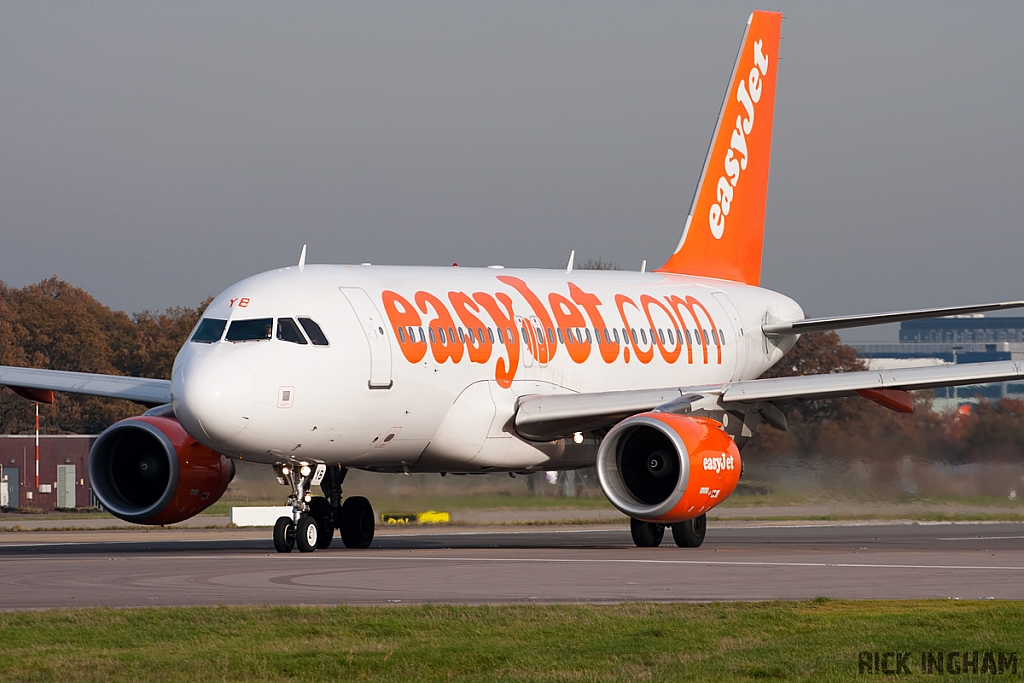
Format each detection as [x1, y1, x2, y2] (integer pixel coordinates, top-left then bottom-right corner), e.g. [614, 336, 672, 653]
[658, 11, 782, 285]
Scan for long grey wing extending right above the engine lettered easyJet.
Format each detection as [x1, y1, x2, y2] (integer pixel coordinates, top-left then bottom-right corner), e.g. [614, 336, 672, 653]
[515, 360, 1024, 440]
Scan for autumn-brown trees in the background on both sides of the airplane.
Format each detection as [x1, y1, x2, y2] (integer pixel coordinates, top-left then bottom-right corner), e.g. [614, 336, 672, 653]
[0, 278, 1024, 462]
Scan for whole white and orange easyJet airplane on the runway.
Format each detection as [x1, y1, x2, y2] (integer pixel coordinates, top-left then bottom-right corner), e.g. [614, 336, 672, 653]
[0, 11, 1024, 553]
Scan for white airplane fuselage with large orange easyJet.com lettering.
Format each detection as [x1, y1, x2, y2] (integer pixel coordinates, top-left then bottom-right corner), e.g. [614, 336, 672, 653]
[172, 265, 803, 472]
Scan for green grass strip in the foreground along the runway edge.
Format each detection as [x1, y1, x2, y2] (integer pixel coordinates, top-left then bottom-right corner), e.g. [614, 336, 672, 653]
[0, 599, 1024, 683]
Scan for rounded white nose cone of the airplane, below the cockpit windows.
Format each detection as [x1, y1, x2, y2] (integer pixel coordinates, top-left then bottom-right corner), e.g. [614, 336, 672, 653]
[171, 357, 256, 451]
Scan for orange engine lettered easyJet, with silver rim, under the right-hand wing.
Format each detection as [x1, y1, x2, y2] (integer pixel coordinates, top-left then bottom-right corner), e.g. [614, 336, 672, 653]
[597, 413, 742, 524]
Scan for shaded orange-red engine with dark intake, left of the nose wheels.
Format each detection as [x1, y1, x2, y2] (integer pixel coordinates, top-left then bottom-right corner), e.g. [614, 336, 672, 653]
[89, 416, 234, 524]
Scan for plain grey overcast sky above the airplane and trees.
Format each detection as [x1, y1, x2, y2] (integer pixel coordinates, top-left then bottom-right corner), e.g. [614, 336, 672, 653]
[0, 0, 1024, 339]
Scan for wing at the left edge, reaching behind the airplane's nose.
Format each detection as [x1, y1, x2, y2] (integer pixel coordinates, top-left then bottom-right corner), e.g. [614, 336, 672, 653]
[0, 366, 171, 407]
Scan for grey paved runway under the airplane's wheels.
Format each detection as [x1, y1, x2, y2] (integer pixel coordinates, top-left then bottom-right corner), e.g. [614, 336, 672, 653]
[0, 523, 1024, 609]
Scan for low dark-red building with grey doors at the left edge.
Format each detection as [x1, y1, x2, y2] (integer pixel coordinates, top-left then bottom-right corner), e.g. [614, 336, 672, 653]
[0, 434, 96, 510]
